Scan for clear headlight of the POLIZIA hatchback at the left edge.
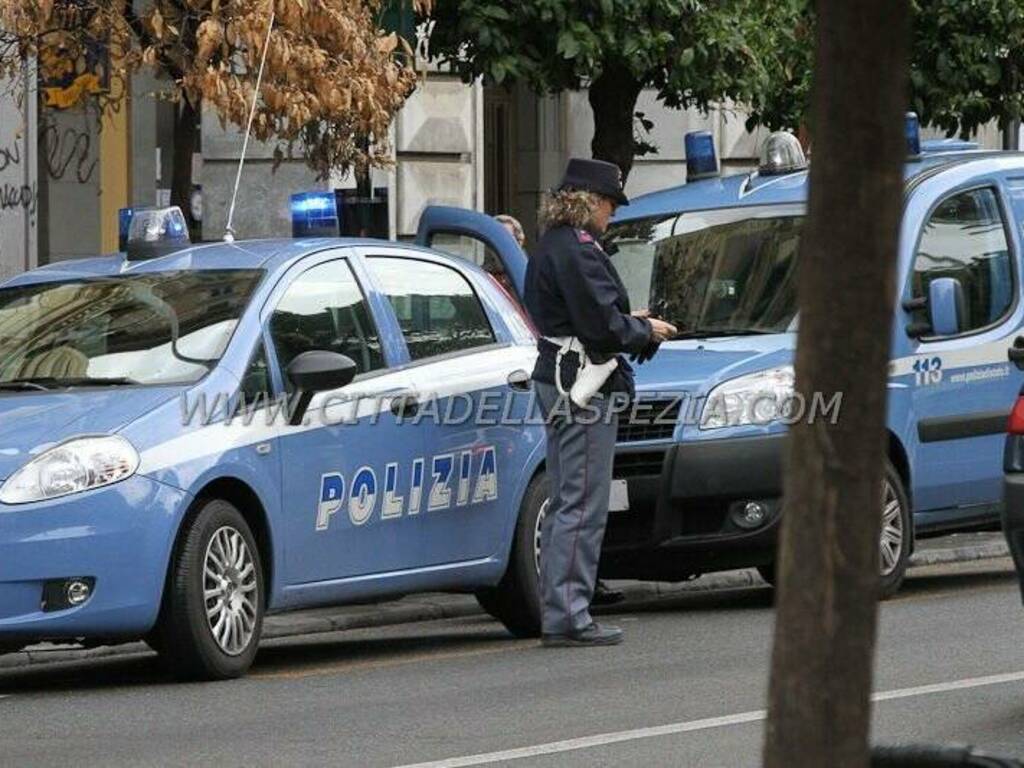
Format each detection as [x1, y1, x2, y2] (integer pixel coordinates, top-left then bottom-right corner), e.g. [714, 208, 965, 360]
[0, 435, 138, 504]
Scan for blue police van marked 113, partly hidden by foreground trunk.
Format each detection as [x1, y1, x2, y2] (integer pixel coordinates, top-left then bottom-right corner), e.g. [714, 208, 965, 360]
[421, 120, 1024, 595]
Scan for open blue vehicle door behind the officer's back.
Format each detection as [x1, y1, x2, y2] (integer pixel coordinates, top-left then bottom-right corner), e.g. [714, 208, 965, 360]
[416, 206, 526, 301]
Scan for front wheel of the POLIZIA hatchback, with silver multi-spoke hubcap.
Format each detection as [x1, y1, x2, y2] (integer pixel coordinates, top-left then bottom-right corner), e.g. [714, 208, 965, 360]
[150, 499, 265, 680]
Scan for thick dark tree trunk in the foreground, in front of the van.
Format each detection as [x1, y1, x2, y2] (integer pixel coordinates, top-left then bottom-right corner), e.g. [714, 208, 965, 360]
[764, 0, 908, 768]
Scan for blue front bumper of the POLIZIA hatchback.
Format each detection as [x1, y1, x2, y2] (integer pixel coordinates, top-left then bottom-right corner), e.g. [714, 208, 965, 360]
[0, 475, 187, 645]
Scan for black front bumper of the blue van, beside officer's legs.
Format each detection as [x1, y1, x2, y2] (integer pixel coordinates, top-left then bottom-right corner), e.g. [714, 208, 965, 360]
[601, 433, 785, 580]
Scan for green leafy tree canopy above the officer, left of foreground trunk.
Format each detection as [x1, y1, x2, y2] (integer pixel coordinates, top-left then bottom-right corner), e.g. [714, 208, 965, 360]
[430, 0, 803, 120]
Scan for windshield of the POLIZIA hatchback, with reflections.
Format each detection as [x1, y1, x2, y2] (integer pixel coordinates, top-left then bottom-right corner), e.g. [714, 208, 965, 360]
[0, 269, 263, 392]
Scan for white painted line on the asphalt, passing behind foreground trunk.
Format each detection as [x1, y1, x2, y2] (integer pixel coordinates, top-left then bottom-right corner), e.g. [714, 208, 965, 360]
[398, 672, 1024, 768]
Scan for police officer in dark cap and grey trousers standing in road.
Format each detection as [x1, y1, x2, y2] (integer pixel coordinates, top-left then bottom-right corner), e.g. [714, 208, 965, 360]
[525, 158, 676, 646]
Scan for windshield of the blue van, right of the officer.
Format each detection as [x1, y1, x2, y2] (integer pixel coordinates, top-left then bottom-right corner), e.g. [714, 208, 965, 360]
[606, 206, 804, 336]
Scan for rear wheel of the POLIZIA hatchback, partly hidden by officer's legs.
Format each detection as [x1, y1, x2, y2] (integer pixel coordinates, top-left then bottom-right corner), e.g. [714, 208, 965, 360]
[476, 474, 549, 637]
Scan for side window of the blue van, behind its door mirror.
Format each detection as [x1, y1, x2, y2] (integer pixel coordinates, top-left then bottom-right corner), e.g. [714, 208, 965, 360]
[911, 187, 1017, 333]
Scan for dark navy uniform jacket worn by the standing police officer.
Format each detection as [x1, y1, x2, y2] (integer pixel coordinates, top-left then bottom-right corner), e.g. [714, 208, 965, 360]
[524, 225, 653, 396]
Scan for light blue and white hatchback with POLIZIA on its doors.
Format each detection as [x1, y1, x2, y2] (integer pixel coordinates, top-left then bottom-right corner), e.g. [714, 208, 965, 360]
[0, 196, 546, 678]
